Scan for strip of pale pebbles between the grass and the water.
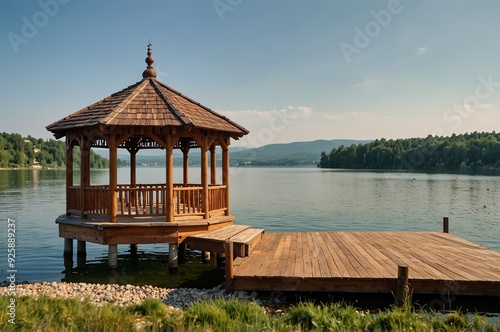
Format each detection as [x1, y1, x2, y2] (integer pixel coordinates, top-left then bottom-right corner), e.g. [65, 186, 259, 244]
[0, 282, 286, 310]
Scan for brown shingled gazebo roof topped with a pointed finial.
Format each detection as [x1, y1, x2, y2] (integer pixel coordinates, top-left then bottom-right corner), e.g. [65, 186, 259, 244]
[46, 45, 248, 138]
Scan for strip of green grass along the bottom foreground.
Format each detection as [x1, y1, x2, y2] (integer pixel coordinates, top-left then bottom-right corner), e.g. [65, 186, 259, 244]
[0, 296, 500, 332]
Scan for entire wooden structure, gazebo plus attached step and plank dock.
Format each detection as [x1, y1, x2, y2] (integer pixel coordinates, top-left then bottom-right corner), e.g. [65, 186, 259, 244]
[47, 43, 500, 295]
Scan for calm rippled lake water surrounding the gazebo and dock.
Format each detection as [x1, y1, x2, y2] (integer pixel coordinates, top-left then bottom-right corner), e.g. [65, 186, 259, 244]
[0, 167, 500, 287]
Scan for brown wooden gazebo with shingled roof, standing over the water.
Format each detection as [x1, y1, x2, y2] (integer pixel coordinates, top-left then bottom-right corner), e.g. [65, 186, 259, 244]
[47, 44, 248, 272]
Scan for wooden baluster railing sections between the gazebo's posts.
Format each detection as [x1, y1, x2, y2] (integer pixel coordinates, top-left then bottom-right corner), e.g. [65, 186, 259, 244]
[67, 184, 227, 217]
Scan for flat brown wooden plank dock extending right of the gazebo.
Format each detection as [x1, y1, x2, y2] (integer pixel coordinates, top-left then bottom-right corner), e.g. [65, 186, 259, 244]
[233, 232, 500, 295]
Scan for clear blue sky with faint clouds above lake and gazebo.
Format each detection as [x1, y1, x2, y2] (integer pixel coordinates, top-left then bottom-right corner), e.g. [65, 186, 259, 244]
[0, 0, 500, 146]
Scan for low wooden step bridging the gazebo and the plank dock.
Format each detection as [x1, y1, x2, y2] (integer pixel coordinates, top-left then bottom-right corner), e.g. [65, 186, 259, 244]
[186, 225, 264, 257]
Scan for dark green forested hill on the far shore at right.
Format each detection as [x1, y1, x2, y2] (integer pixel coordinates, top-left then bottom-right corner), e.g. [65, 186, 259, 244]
[318, 132, 500, 170]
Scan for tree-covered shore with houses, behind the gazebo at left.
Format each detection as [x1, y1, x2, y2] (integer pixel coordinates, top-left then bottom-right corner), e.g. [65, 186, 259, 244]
[0, 132, 114, 168]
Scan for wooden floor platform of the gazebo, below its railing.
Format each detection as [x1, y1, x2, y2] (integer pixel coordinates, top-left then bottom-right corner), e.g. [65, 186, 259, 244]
[56, 214, 235, 245]
